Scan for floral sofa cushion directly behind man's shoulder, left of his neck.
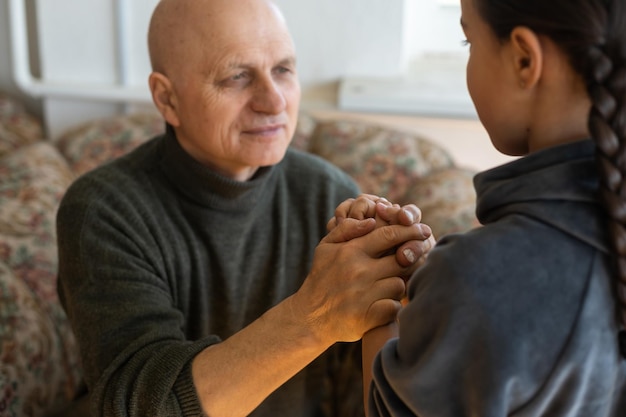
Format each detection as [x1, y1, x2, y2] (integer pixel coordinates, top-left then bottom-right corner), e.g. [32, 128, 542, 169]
[57, 113, 165, 175]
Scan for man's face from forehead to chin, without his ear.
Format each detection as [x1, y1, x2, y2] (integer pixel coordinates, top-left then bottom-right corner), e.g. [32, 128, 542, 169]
[161, 2, 300, 181]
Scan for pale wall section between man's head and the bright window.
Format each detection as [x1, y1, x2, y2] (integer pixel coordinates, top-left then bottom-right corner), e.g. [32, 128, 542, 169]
[276, 0, 404, 82]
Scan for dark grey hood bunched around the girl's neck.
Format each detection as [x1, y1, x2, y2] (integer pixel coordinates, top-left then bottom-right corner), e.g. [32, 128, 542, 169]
[474, 140, 608, 251]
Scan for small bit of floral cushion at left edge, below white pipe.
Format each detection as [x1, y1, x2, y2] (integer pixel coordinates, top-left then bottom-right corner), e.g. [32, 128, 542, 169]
[0, 93, 43, 156]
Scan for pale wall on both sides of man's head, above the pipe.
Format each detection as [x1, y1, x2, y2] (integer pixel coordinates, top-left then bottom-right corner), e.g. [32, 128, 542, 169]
[38, 0, 403, 88]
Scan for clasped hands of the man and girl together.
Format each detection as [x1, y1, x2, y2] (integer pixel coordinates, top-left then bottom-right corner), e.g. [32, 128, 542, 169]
[292, 194, 435, 345]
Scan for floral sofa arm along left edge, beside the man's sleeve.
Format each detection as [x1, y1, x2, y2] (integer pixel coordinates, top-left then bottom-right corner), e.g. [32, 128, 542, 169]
[0, 142, 81, 416]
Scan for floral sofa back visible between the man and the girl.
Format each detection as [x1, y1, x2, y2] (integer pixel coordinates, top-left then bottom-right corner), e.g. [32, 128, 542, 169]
[310, 120, 477, 237]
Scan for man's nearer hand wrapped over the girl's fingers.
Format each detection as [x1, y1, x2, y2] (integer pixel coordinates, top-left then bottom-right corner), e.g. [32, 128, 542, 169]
[291, 218, 427, 343]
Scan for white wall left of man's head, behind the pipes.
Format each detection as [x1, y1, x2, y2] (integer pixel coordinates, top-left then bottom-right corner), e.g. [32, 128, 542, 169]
[36, 0, 158, 138]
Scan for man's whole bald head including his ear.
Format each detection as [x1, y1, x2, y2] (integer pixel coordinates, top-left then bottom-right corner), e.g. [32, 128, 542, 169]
[148, 0, 300, 180]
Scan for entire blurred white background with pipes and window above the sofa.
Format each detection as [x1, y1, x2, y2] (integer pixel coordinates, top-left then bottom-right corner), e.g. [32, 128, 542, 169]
[0, 0, 512, 169]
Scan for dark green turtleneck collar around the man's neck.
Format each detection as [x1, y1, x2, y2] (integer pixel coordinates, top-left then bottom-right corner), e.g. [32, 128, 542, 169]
[159, 125, 275, 211]
